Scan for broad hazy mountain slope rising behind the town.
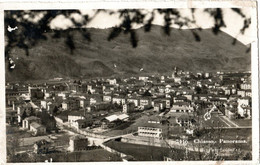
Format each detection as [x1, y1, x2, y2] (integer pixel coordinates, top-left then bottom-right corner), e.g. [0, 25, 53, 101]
[6, 25, 251, 81]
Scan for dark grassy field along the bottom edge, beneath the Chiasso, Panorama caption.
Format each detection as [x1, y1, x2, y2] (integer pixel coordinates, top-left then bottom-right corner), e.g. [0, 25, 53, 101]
[105, 133, 251, 161]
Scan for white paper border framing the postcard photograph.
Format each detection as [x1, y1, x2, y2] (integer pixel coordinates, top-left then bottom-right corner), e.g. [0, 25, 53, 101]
[0, 0, 259, 164]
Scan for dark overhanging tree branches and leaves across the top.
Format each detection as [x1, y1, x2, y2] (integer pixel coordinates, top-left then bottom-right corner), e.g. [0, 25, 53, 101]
[4, 8, 251, 71]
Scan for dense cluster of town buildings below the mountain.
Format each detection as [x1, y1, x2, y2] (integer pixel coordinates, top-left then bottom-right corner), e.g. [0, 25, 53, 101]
[6, 68, 252, 152]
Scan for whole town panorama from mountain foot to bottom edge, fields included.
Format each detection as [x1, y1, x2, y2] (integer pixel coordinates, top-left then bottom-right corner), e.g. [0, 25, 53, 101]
[6, 67, 252, 162]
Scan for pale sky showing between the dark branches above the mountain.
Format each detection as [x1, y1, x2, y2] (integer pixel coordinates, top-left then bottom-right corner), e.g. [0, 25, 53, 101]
[50, 8, 254, 44]
